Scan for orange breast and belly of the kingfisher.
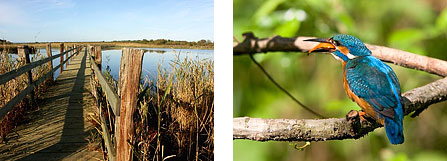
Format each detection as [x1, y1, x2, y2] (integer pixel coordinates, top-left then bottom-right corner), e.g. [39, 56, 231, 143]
[343, 62, 385, 125]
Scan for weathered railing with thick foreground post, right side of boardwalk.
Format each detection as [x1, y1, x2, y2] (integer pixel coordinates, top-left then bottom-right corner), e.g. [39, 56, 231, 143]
[86, 46, 144, 161]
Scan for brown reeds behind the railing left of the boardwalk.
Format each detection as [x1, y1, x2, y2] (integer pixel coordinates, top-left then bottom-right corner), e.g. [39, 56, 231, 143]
[0, 49, 53, 143]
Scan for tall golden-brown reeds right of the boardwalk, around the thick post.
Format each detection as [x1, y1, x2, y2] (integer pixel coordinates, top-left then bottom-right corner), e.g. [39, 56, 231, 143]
[90, 52, 214, 161]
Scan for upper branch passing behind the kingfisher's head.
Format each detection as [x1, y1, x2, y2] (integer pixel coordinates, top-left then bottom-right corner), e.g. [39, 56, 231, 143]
[233, 32, 447, 77]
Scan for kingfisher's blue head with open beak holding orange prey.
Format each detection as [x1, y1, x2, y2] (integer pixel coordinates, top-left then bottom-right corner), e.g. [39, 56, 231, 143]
[304, 34, 371, 62]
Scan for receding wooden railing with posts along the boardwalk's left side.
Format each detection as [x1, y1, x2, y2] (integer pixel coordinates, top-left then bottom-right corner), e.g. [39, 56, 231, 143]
[0, 46, 81, 119]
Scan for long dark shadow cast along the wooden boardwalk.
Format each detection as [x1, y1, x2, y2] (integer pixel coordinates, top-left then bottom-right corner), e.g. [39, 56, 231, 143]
[20, 51, 88, 160]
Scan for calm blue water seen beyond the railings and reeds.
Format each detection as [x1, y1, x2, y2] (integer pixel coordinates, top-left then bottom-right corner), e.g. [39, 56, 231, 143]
[11, 48, 214, 80]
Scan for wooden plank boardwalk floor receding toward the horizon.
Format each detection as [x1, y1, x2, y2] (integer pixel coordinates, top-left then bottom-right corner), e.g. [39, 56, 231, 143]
[0, 48, 102, 160]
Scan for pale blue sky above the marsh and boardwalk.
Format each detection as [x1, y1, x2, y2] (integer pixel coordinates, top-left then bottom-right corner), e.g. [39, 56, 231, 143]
[0, 0, 214, 42]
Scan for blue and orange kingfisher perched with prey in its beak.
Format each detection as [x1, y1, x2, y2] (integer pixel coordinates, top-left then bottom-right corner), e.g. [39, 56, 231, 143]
[304, 34, 404, 144]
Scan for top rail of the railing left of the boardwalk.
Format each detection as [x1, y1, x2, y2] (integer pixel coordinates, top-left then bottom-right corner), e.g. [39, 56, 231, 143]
[0, 47, 76, 85]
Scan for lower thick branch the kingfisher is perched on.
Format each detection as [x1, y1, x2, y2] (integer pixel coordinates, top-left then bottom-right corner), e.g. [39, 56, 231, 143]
[233, 78, 447, 141]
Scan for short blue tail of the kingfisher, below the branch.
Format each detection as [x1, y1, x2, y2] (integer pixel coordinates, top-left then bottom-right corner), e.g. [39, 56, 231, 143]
[385, 116, 404, 144]
